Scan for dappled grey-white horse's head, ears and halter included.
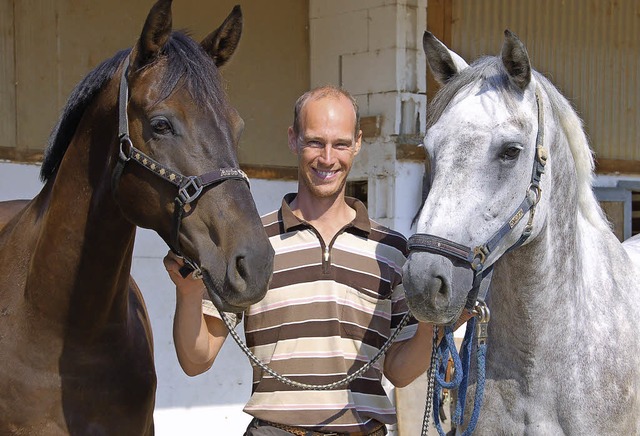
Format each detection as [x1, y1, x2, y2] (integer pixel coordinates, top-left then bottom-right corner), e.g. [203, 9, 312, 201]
[404, 31, 550, 324]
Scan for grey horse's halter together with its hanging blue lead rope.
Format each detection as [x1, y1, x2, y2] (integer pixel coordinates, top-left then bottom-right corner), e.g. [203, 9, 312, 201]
[407, 88, 548, 436]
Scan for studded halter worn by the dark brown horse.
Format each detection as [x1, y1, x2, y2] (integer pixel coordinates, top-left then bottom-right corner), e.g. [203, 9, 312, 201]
[111, 56, 249, 276]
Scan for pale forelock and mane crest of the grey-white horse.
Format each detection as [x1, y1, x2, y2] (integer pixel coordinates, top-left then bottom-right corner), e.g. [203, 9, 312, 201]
[427, 56, 610, 230]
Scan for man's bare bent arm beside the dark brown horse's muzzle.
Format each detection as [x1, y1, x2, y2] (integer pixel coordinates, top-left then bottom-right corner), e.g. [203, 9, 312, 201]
[164, 252, 228, 376]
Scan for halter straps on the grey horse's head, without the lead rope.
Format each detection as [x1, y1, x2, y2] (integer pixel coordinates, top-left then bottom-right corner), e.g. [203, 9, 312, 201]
[407, 88, 547, 309]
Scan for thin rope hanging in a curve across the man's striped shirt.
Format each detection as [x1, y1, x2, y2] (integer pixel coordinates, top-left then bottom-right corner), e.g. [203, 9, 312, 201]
[218, 309, 412, 391]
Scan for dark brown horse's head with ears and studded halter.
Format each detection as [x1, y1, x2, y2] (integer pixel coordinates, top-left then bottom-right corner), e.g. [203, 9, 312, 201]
[111, 0, 273, 311]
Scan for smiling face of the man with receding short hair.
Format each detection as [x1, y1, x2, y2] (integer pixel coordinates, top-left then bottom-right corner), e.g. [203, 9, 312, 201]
[289, 96, 362, 198]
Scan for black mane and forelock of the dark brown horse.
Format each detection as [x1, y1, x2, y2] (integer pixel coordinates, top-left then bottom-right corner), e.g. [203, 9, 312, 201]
[40, 31, 227, 182]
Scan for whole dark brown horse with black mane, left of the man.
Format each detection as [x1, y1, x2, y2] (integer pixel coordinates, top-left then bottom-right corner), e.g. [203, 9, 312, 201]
[0, 0, 273, 436]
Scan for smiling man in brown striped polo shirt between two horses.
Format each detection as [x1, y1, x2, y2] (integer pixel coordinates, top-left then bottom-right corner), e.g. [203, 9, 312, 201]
[165, 86, 440, 436]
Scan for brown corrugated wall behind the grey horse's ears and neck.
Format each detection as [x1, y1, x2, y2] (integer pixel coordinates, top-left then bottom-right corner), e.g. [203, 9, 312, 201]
[451, 0, 640, 160]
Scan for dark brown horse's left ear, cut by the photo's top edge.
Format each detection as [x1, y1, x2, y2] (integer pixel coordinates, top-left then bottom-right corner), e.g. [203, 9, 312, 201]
[131, 0, 171, 70]
